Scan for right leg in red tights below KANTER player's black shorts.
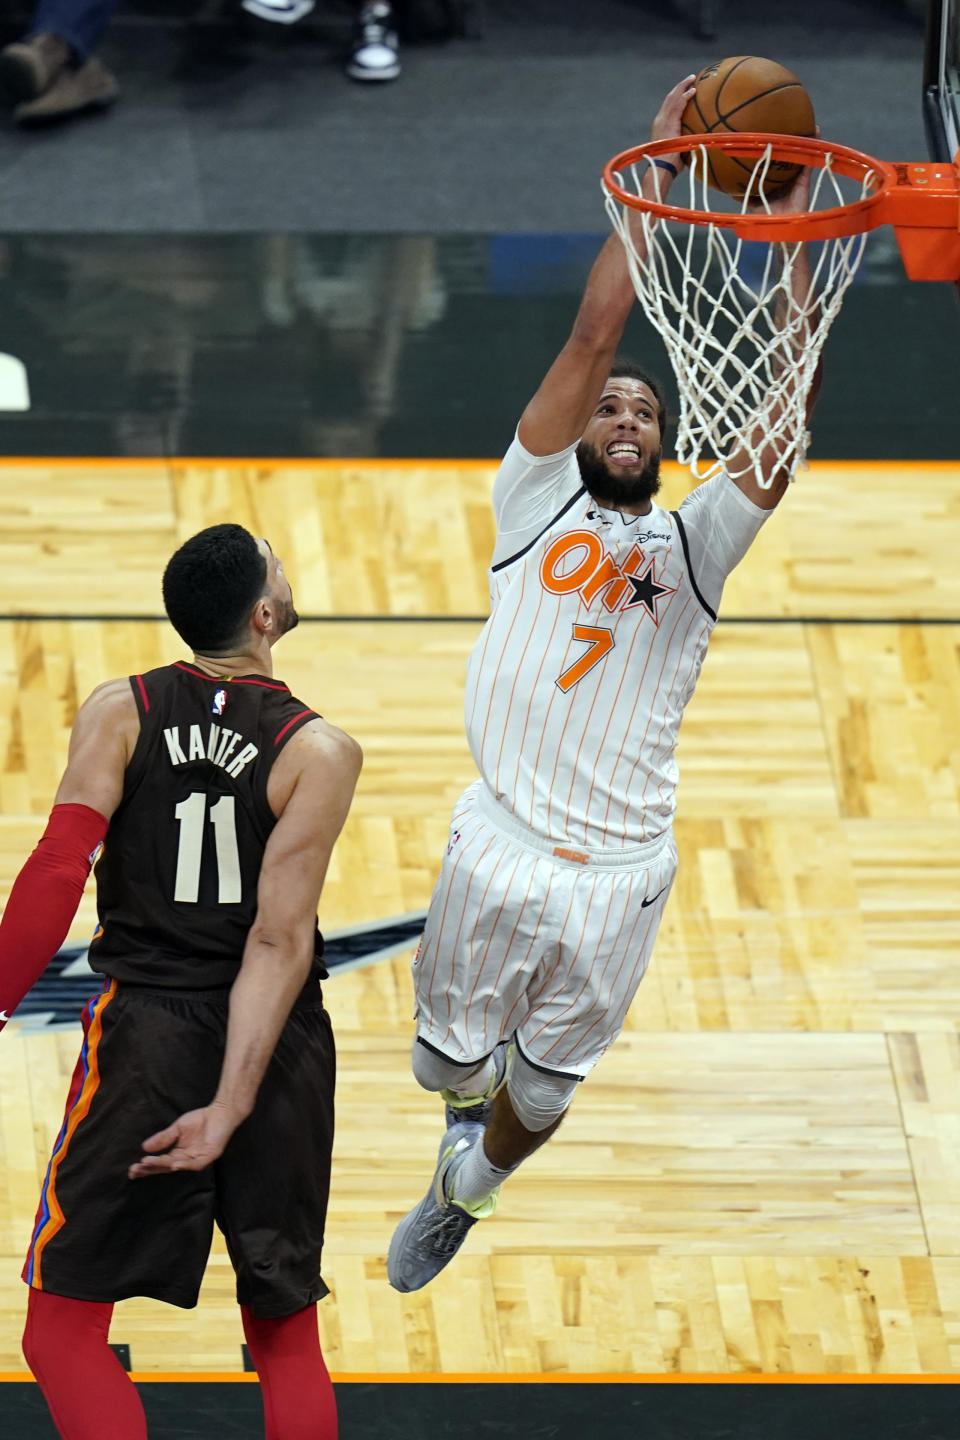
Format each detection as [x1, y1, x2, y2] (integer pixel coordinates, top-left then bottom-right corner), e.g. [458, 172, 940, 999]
[240, 1305, 337, 1440]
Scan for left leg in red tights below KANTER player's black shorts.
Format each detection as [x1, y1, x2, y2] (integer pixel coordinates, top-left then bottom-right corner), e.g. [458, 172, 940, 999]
[23, 1289, 147, 1440]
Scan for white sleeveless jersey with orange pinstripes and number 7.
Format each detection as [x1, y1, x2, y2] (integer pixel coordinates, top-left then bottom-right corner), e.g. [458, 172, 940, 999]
[466, 480, 711, 850]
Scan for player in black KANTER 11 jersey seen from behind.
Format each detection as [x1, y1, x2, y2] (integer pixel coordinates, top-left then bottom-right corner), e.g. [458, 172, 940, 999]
[0, 526, 360, 1440]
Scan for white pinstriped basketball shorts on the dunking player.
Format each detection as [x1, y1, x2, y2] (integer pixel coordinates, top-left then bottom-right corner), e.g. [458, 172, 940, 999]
[413, 780, 676, 1079]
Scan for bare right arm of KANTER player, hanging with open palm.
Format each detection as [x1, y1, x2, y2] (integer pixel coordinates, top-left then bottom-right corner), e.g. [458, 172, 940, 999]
[128, 720, 361, 1179]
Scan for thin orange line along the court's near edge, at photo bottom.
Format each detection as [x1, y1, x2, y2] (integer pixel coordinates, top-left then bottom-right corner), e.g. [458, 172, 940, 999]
[0, 1369, 960, 1385]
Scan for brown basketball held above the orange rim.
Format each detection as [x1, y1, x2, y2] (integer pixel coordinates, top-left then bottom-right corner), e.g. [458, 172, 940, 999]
[681, 55, 816, 199]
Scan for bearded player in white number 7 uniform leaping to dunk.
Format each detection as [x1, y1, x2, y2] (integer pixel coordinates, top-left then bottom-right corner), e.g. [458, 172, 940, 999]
[387, 76, 813, 1290]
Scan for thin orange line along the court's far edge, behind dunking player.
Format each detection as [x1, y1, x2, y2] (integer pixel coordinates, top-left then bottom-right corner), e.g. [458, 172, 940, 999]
[0, 455, 960, 471]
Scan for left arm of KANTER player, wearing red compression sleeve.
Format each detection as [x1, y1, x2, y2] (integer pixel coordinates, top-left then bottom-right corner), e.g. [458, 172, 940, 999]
[0, 680, 140, 1030]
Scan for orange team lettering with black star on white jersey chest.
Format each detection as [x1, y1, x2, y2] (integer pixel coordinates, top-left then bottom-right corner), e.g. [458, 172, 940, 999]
[540, 530, 676, 625]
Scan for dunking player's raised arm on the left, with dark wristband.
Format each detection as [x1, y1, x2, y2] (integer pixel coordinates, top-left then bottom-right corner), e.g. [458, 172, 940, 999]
[518, 75, 694, 455]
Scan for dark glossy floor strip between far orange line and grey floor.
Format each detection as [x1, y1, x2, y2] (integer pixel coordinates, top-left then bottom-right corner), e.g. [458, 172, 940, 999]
[0, 232, 960, 459]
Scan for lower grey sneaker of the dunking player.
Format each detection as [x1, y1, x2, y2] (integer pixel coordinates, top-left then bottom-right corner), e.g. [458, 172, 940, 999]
[387, 1125, 498, 1293]
